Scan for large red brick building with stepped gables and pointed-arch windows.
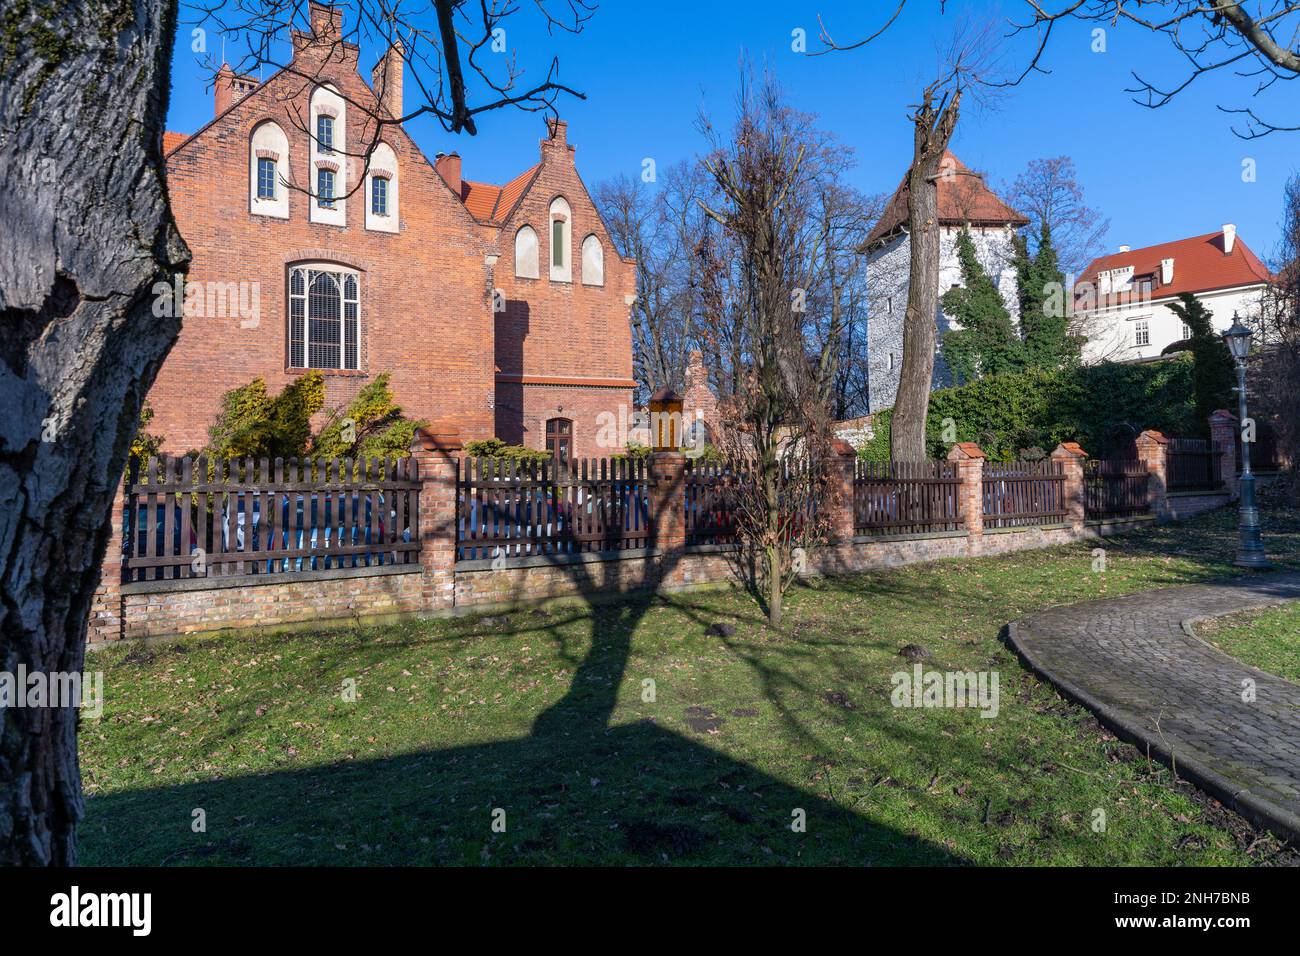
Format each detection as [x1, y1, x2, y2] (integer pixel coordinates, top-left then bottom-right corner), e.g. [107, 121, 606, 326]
[150, 4, 636, 457]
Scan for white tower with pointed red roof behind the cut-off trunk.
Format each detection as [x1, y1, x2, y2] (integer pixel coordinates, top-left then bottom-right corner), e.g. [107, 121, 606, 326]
[858, 151, 1028, 412]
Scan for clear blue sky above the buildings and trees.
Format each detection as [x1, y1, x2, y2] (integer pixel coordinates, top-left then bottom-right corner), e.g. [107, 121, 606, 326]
[168, 0, 1300, 265]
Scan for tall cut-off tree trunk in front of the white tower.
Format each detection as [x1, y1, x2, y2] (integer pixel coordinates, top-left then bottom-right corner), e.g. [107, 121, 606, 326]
[889, 88, 961, 462]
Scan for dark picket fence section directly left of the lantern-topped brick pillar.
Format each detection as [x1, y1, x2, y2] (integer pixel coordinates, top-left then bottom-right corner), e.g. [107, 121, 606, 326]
[456, 458, 651, 561]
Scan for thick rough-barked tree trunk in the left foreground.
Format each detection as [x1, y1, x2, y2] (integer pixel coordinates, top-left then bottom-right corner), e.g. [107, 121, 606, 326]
[0, 0, 189, 865]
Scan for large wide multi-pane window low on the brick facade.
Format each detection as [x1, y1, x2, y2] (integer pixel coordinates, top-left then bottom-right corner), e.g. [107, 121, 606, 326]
[289, 263, 361, 371]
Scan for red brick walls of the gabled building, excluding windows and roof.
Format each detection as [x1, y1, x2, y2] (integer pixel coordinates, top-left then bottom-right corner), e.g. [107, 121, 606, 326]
[150, 12, 634, 463]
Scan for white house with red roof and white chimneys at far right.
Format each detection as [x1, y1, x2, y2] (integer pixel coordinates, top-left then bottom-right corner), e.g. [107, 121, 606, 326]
[1074, 222, 1270, 362]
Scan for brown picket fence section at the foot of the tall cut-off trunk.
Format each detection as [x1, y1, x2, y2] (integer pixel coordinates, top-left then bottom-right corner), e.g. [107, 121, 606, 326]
[853, 460, 965, 535]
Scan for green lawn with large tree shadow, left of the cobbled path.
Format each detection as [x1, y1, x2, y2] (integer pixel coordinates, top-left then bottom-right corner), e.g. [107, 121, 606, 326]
[81, 511, 1300, 865]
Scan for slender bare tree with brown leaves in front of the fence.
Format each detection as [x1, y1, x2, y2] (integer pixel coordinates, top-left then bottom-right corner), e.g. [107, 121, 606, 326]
[703, 77, 839, 627]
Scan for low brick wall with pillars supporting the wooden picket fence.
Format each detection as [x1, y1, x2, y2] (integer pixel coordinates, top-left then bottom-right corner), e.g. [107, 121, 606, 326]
[90, 432, 1226, 643]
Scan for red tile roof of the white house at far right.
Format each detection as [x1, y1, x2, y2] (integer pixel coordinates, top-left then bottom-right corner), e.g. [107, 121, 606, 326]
[1075, 230, 1273, 304]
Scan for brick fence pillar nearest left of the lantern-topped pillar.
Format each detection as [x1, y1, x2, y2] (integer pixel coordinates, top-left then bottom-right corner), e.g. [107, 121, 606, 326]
[411, 427, 460, 611]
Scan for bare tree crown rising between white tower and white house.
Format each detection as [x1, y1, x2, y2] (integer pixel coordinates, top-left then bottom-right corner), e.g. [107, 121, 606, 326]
[1006, 156, 1110, 274]
